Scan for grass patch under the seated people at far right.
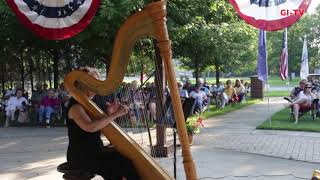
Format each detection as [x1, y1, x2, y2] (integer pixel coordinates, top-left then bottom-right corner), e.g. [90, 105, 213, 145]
[257, 108, 320, 132]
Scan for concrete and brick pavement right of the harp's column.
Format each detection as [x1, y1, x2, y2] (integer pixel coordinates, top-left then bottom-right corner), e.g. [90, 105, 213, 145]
[189, 98, 320, 180]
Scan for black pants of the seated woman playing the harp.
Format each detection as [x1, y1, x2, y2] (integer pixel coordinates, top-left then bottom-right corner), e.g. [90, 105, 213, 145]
[75, 148, 140, 180]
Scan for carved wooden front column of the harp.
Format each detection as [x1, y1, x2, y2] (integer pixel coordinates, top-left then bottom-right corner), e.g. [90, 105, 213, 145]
[148, 3, 197, 180]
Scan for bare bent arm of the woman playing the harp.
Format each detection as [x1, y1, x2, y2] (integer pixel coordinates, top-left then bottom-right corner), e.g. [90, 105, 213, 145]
[68, 104, 128, 132]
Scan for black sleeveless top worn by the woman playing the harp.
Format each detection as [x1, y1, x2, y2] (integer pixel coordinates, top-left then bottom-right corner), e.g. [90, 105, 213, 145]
[66, 98, 103, 164]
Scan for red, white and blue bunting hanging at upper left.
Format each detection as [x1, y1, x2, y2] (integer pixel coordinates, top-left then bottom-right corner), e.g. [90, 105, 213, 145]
[6, 0, 100, 40]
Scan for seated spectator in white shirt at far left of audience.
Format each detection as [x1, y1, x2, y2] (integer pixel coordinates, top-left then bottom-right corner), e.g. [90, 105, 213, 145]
[5, 89, 29, 127]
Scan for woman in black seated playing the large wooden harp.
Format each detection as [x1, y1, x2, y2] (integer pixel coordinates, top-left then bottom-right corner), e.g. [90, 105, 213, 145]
[67, 69, 140, 180]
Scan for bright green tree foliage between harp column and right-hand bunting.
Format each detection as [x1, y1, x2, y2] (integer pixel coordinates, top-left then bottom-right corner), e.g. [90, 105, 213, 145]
[168, 0, 257, 80]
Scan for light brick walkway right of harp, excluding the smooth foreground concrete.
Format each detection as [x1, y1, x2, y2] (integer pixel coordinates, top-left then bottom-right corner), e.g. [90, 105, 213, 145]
[199, 98, 320, 163]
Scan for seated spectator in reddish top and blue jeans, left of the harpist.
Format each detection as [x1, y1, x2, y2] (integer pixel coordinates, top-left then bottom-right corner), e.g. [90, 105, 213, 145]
[39, 89, 60, 127]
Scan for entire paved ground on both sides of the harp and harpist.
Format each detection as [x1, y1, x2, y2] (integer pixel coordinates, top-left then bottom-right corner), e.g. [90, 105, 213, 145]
[0, 99, 320, 180]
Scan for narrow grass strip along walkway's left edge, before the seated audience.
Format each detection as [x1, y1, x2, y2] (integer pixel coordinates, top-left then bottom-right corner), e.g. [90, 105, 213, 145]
[188, 99, 262, 119]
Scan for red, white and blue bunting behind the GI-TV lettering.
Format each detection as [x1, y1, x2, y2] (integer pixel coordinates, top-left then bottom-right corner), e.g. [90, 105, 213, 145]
[230, 0, 311, 31]
